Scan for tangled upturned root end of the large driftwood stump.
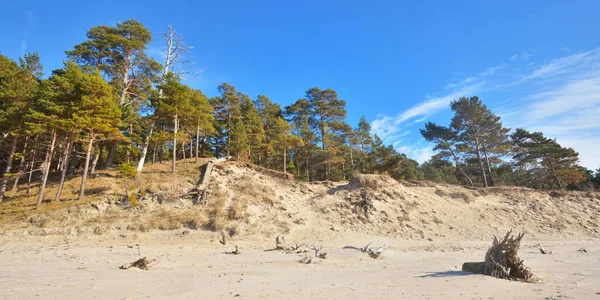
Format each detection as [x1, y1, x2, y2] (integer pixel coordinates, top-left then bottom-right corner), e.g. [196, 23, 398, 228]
[484, 230, 535, 281]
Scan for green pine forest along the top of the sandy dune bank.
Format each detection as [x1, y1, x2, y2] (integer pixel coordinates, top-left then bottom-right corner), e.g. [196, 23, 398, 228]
[0, 20, 600, 206]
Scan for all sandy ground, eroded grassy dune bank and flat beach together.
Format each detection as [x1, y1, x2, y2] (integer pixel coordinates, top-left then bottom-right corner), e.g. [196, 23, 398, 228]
[0, 163, 600, 299]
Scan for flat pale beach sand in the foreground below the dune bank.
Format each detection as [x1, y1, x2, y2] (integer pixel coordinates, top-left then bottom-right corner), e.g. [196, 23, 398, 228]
[0, 232, 600, 299]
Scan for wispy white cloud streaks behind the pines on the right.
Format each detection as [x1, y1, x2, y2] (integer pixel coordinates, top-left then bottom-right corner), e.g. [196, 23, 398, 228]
[372, 48, 600, 169]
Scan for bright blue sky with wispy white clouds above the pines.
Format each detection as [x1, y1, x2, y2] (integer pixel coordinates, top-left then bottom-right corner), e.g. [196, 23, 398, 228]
[0, 0, 600, 169]
